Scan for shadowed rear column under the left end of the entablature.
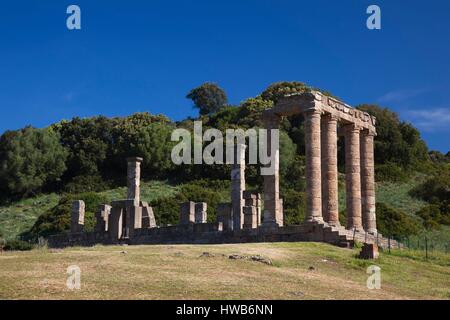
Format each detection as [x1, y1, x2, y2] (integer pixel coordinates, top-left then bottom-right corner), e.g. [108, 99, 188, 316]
[260, 115, 284, 227]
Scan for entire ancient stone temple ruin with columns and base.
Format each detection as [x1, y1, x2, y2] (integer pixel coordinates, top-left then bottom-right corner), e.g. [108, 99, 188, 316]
[49, 91, 398, 247]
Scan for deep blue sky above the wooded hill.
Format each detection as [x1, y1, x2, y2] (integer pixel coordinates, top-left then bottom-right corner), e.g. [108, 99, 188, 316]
[0, 0, 450, 152]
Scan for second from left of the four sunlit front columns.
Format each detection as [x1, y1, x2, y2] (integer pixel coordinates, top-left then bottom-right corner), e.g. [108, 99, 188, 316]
[321, 114, 340, 226]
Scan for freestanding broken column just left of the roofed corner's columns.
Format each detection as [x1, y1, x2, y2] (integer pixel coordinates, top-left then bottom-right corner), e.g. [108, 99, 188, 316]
[231, 144, 246, 230]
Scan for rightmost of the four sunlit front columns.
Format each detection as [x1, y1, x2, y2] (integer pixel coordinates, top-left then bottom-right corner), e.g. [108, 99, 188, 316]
[361, 130, 377, 233]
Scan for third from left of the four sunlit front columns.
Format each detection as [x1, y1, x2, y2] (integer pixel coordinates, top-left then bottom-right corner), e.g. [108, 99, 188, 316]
[344, 124, 363, 231]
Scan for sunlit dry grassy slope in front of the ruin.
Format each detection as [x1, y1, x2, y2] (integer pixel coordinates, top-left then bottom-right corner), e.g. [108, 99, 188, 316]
[0, 243, 450, 299]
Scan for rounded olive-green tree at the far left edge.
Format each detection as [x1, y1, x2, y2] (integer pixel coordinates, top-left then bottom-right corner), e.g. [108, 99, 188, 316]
[0, 127, 67, 196]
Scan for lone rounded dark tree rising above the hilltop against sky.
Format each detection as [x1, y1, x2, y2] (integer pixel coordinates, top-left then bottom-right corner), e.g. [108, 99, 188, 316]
[186, 82, 228, 115]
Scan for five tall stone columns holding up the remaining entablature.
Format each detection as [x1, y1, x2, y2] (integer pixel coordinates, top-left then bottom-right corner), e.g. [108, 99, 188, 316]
[263, 108, 377, 233]
